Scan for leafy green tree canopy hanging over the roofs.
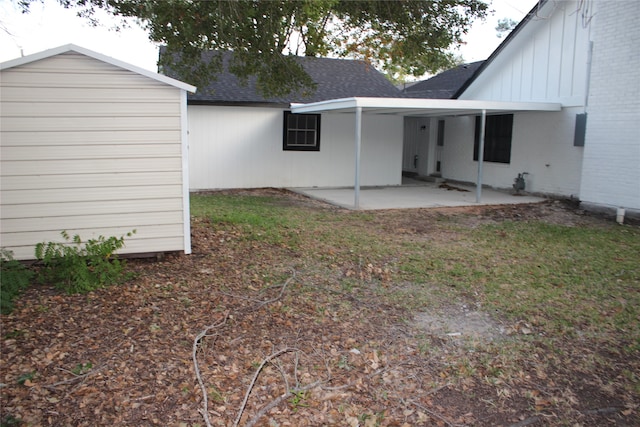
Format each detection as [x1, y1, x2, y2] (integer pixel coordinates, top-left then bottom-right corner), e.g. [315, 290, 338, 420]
[21, 0, 488, 96]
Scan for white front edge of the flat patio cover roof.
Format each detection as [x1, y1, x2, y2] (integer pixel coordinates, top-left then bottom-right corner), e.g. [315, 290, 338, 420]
[291, 98, 562, 115]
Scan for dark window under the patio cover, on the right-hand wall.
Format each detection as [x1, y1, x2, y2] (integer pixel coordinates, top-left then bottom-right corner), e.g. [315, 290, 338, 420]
[473, 114, 513, 163]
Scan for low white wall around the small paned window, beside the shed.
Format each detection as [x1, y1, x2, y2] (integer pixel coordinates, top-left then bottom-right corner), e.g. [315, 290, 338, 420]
[188, 105, 403, 191]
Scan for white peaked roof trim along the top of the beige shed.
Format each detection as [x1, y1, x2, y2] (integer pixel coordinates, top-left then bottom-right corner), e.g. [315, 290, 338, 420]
[0, 44, 196, 93]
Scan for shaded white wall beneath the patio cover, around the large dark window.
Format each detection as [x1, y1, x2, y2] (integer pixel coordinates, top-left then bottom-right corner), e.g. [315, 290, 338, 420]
[442, 109, 582, 197]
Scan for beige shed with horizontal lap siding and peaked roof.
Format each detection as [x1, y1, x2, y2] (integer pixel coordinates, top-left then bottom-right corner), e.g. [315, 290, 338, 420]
[0, 45, 195, 260]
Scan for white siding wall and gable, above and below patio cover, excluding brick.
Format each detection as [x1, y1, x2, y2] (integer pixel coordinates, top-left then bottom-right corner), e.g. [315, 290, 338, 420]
[442, 0, 591, 198]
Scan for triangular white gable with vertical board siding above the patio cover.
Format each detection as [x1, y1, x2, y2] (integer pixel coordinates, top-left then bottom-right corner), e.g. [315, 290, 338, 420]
[460, 0, 592, 107]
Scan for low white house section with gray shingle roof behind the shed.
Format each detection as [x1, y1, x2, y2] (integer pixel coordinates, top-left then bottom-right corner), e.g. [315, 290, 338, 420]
[161, 51, 403, 191]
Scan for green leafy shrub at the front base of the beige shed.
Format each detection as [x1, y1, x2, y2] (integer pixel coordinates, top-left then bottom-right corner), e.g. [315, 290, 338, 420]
[36, 230, 135, 294]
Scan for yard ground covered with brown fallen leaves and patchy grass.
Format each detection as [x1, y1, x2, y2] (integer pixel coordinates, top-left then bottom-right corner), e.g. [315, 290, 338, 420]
[0, 190, 640, 427]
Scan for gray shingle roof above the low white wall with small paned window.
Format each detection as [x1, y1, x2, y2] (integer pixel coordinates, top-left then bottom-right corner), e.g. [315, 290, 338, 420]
[160, 49, 402, 105]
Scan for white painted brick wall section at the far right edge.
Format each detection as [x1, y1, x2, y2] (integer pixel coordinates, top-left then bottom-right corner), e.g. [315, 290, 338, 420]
[580, 1, 640, 210]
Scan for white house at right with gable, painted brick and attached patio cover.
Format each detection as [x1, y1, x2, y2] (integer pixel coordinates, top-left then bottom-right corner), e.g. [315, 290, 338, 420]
[292, 0, 640, 214]
